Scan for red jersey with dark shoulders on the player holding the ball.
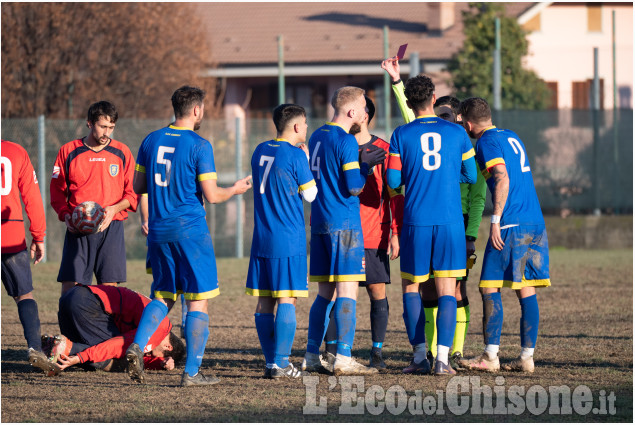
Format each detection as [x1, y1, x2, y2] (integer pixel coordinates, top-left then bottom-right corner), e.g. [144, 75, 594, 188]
[51, 139, 137, 221]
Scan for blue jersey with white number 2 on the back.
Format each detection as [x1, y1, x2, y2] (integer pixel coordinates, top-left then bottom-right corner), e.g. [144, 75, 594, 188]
[476, 126, 545, 227]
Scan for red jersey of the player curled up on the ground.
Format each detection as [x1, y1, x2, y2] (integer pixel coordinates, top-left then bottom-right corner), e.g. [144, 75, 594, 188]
[77, 285, 172, 369]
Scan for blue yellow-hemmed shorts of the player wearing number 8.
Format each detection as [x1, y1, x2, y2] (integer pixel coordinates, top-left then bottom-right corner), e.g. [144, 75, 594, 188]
[399, 221, 466, 283]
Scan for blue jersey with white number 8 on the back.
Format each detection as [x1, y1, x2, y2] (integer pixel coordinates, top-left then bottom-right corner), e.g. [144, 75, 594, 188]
[389, 115, 474, 226]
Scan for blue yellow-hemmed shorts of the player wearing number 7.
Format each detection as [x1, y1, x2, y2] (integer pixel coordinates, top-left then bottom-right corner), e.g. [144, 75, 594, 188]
[245, 255, 309, 298]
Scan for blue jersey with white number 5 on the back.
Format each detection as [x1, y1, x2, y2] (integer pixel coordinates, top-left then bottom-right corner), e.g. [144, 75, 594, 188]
[136, 125, 216, 243]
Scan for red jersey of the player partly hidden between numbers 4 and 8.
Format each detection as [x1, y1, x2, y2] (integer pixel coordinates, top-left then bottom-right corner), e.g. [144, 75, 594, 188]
[359, 136, 404, 249]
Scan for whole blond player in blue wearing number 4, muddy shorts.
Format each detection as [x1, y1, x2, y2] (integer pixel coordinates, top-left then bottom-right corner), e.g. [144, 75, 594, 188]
[302, 86, 386, 375]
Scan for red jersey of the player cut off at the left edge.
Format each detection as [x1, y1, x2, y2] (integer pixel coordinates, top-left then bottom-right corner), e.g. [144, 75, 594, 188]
[0, 140, 46, 254]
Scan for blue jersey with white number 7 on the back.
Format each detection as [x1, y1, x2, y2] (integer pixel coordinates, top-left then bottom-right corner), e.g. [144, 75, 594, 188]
[251, 139, 315, 258]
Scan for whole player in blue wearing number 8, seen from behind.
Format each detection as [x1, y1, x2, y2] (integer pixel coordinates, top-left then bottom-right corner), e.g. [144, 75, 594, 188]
[387, 75, 476, 375]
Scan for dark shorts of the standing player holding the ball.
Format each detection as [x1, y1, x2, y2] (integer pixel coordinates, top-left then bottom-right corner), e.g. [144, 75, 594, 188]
[57, 220, 126, 285]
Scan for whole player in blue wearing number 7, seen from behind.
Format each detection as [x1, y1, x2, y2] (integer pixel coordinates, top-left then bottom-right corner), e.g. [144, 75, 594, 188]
[246, 104, 317, 379]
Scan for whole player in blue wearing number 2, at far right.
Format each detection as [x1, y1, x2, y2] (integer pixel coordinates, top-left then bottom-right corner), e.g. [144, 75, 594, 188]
[461, 97, 551, 373]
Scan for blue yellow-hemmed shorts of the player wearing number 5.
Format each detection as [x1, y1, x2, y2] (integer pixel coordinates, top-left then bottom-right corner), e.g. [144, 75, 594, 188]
[148, 233, 219, 301]
